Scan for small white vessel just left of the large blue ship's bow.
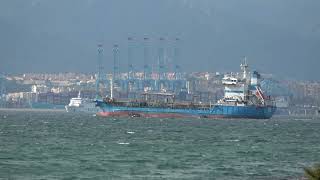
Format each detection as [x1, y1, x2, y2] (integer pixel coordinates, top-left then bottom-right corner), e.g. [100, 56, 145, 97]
[65, 91, 100, 114]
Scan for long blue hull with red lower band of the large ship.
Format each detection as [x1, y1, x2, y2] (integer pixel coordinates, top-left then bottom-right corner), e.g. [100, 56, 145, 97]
[97, 102, 276, 119]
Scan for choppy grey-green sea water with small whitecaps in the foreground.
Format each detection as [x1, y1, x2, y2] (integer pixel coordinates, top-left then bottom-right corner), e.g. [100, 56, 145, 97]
[0, 111, 320, 179]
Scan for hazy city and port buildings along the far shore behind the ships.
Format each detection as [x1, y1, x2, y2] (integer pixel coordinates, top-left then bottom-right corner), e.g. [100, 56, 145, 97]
[0, 72, 320, 114]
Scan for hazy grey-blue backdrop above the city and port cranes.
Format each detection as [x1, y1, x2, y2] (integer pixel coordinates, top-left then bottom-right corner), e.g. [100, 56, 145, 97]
[0, 0, 320, 80]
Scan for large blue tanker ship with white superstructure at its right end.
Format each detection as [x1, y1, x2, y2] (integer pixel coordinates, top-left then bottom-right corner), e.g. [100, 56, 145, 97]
[96, 59, 276, 119]
